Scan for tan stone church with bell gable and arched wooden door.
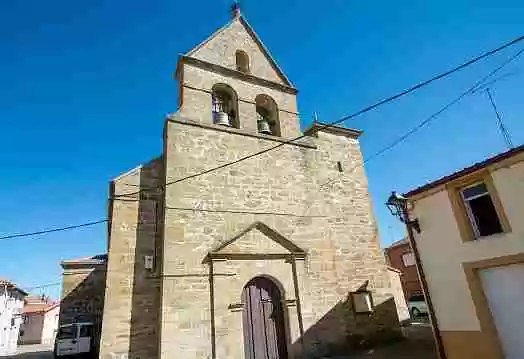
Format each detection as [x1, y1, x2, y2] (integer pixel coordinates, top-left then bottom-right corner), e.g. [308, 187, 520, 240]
[96, 9, 400, 359]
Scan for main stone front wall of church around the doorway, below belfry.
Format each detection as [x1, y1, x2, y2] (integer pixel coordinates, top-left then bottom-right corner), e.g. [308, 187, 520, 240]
[160, 117, 398, 359]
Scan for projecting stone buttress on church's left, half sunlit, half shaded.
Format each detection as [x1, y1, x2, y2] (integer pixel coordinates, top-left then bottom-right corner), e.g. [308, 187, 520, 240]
[100, 158, 164, 359]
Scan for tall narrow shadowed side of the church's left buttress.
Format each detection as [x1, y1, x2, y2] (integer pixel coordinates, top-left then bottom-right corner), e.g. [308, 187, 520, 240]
[128, 159, 163, 359]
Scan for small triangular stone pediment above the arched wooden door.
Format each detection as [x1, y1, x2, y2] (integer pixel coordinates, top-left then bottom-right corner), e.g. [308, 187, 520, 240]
[210, 222, 305, 255]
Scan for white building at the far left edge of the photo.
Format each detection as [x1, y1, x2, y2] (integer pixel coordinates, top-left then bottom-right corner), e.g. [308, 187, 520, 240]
[0, 279, 27, 356]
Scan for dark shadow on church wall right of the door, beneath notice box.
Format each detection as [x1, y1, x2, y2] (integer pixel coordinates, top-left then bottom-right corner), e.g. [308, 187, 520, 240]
[290, 294, 403, 358]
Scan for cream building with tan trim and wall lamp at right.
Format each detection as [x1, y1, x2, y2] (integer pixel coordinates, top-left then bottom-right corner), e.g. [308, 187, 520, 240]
[406, 146, 524, 359]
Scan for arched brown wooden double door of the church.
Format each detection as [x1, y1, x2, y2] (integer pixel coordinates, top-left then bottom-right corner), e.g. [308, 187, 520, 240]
[242, 277, 287, 359]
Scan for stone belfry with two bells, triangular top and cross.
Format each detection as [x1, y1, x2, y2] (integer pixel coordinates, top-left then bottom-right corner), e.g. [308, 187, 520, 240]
[172, 7, 300, 138]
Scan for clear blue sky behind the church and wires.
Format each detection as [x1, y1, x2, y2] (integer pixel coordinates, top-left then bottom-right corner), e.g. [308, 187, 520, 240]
[0, 0, 524, 296]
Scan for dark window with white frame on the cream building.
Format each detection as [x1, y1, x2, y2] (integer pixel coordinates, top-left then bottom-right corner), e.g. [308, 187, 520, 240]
[460, 182, 503, 238]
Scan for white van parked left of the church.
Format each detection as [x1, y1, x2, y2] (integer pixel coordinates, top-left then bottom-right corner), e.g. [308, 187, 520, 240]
[54, 322, 94, 358]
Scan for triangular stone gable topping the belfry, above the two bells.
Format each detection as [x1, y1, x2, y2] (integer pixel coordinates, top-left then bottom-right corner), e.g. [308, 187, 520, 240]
[186, 16, 293, 87]
